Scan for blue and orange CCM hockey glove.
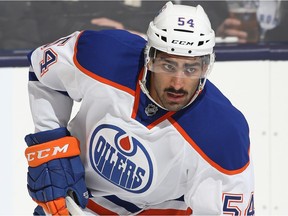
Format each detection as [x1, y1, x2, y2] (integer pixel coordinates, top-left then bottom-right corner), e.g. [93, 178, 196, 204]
[25, 128, 88, 215]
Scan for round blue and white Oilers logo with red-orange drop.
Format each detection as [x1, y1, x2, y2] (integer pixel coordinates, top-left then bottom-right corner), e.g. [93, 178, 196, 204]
[89, 124, 153, 193]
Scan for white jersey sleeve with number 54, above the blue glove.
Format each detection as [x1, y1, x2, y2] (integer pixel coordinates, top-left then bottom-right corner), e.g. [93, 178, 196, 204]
[28, 32, 82, 132]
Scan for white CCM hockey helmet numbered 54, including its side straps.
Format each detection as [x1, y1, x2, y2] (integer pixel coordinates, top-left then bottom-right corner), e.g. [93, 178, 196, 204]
[140, 1, 215, 109]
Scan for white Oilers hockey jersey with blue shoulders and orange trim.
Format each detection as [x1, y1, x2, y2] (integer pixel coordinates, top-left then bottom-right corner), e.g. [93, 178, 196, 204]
[29, 30, 254, 215]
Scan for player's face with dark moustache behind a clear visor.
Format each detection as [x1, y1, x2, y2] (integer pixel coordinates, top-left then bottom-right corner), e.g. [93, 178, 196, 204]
[148, 53, 204, 111]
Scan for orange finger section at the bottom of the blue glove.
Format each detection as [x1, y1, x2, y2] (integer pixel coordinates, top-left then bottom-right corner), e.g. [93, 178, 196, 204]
[34, 197, 69, 215]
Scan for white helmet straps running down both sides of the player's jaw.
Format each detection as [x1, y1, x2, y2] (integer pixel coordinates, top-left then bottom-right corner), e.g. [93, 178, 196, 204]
[139, 66, 207, 111]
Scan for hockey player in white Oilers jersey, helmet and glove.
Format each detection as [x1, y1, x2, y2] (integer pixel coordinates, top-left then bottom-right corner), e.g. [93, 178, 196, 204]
[25, 2, 254, 215]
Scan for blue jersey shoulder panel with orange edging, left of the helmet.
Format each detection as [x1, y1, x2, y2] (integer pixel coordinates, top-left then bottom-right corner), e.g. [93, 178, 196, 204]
[74, 30, 146, 90]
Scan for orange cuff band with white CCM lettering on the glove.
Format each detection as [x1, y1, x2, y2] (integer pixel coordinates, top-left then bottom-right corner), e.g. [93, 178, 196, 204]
[25, 136, 80, 167]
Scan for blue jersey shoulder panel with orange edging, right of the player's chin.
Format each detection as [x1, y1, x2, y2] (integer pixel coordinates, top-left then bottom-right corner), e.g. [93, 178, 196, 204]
[173, 81, 250, 174]
